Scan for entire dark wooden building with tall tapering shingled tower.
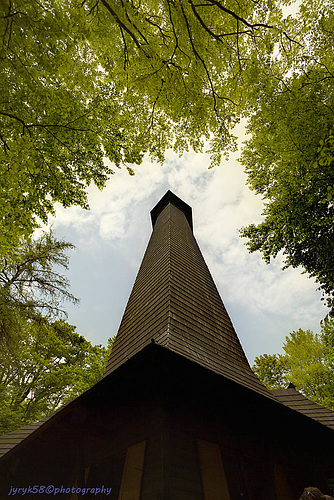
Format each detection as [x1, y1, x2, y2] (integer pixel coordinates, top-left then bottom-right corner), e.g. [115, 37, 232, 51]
[0, 191, 334, 500]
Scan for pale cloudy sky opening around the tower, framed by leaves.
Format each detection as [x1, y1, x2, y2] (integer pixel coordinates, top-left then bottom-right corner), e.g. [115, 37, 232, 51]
[50, 123, 328, 364]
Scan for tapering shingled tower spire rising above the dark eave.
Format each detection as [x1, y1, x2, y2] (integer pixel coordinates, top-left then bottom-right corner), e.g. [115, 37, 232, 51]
[105, 192, 272, 399]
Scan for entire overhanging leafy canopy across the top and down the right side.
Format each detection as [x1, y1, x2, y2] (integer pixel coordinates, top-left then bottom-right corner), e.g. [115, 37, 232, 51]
[0, 0, 334, 306]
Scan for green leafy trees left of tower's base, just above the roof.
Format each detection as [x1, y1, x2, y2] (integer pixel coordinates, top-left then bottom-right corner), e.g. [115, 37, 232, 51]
[0, 315, 112, 433]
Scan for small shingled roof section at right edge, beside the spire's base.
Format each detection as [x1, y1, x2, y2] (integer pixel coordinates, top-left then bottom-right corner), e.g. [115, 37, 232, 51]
[270, 388, 334, 430]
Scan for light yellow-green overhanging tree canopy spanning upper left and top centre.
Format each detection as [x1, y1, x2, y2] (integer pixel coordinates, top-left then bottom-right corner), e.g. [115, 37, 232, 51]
[0, 0, 291, 256]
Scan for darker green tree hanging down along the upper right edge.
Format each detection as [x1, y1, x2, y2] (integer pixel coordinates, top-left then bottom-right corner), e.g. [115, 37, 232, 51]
[241, 1, 334, 313]
